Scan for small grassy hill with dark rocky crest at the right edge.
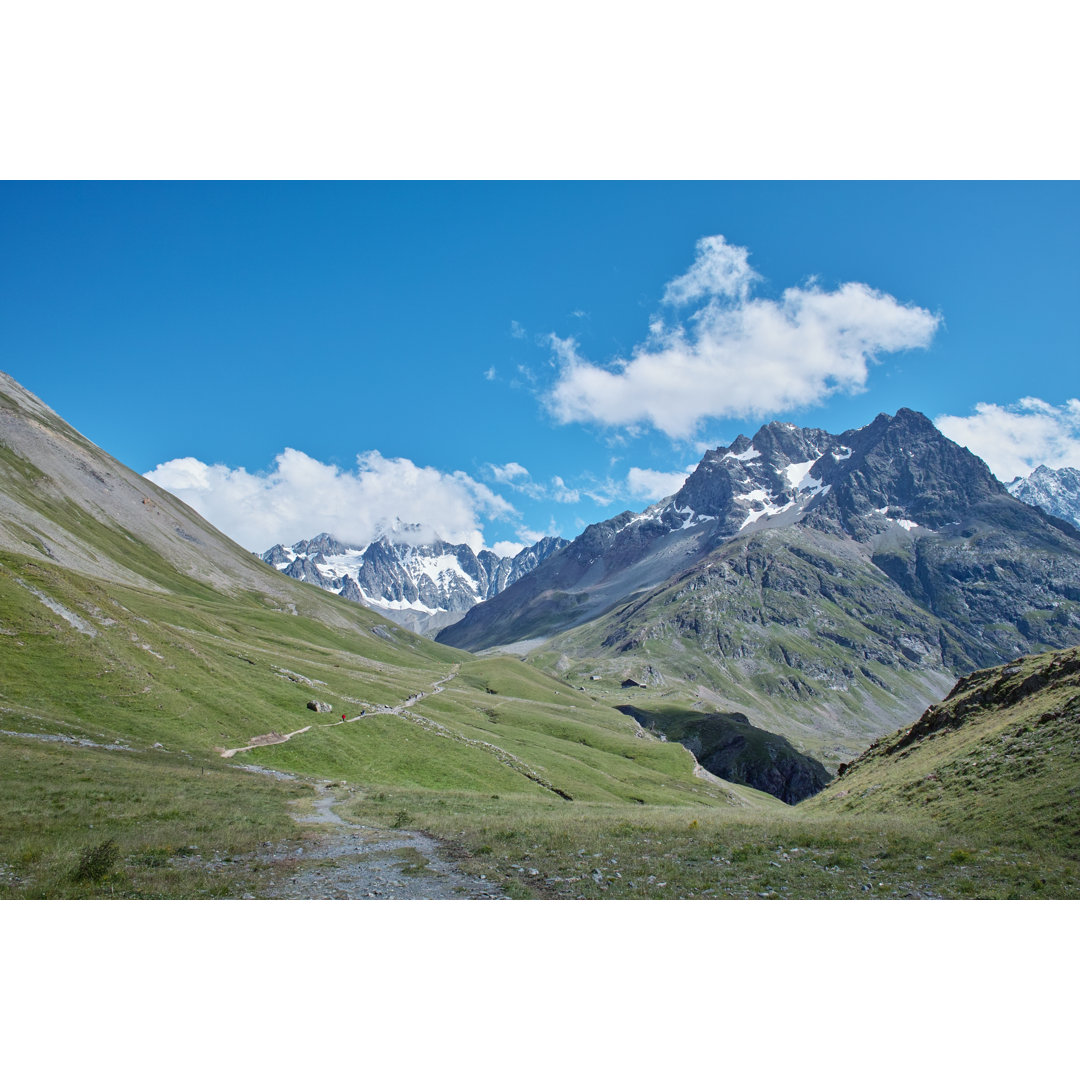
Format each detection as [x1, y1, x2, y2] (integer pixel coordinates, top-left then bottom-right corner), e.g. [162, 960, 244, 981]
[810, 648, 1080, 859]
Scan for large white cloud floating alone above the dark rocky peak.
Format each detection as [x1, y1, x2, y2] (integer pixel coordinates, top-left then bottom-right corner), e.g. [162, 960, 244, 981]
[546, 237, 941, 438]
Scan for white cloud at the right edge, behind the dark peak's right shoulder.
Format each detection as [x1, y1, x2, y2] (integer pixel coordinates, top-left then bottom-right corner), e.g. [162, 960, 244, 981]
[934, 397, 1080, 483]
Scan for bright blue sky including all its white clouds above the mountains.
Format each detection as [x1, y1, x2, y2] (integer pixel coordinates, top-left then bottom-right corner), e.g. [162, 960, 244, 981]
[0, 181, 1080, 550]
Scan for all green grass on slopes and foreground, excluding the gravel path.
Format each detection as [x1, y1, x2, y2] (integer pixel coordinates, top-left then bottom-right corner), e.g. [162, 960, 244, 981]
[0, 555, 1080, 899]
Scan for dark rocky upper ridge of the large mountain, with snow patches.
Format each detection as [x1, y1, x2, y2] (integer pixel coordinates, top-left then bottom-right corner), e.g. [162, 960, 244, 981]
[440, 409, 1062, 649]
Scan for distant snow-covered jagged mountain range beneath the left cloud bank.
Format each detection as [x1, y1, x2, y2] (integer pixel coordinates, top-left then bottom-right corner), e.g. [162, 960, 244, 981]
[261, 532, 568, 634]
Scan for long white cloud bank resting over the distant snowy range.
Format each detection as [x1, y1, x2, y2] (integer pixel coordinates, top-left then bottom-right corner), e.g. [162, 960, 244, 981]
[145, 449, 517, 551]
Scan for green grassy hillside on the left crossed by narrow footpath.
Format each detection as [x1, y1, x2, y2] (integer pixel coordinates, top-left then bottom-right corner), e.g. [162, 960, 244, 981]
[0, 552, 734, 896]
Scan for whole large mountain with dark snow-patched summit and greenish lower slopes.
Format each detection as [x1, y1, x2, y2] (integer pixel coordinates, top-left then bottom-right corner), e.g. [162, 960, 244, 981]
[437, 409, 1080, 766]
